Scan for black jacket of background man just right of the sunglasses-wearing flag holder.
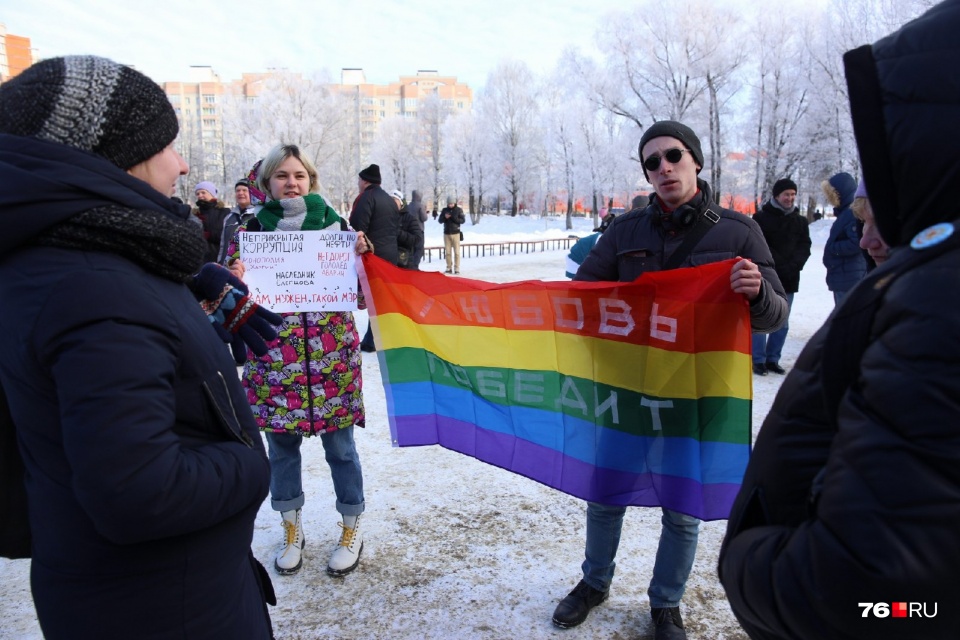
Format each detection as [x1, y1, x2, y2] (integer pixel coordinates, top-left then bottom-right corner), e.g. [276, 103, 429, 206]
[753, 200, 811, 293]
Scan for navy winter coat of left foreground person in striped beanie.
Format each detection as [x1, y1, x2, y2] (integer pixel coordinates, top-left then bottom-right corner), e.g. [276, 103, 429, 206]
[0, 136, 270, 639]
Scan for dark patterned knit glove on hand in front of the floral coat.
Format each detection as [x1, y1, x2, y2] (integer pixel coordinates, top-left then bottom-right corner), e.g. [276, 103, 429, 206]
[192, 262, 283, 364]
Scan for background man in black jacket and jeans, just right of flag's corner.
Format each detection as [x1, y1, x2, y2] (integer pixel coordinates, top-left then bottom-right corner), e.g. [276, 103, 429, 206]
[753, 178, 811, 376]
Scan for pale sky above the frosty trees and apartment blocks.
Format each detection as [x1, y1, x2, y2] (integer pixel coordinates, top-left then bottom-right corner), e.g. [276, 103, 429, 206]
[7, 0, 633, 88]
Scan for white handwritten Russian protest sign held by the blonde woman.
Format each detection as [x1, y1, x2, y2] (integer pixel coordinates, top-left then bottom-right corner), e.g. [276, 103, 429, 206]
[240, 231, 357, 313]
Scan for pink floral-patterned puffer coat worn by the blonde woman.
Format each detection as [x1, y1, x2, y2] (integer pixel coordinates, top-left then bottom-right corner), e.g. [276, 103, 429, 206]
[230, 219, 366, 436]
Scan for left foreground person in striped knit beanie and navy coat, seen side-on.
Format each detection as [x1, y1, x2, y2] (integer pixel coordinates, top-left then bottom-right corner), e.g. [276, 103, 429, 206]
[0, 56, 276, 640]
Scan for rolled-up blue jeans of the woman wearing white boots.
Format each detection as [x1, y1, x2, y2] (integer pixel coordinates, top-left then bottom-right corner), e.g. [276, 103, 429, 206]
[267, 427, 364, 516]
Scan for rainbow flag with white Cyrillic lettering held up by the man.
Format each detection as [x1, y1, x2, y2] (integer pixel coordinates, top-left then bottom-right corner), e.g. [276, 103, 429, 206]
[357, 255, 753, 520]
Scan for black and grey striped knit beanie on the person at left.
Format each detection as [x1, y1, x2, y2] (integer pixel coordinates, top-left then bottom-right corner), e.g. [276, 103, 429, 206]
[0, 56, 179, 169]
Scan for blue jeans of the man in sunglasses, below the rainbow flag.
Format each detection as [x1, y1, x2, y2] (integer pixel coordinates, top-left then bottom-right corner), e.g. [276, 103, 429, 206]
[582, 502, 700, 609]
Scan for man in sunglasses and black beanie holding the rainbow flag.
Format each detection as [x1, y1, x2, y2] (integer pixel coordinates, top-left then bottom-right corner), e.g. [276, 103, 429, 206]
[553, 121, 788, 640]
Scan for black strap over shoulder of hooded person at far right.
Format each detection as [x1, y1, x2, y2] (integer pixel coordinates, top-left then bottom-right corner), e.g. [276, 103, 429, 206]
[820, 221, 960, 416]
